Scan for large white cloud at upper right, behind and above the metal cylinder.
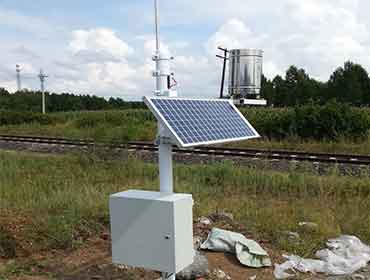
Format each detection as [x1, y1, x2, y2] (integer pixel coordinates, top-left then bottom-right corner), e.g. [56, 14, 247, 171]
[202, 0, 370, 81]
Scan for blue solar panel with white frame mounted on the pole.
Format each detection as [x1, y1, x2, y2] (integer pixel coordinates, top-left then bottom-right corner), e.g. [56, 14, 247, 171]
[144, 97, 260, 147]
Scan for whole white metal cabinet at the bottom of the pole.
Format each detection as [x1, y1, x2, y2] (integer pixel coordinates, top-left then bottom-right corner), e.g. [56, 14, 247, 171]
[110, 190, 194, 273]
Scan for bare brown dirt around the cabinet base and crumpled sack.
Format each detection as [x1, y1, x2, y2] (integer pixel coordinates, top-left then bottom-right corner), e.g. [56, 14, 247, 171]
[0, 211, 281, 280]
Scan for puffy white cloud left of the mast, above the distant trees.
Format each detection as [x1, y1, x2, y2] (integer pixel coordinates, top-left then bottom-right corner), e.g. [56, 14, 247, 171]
[47, 28, 137, 97]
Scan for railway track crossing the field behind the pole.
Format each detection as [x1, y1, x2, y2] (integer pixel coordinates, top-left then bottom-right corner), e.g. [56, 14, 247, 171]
[0, 135, 370, 165]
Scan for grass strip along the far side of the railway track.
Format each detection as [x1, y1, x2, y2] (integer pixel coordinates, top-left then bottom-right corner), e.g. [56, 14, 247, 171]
[0, 109, 370, 154]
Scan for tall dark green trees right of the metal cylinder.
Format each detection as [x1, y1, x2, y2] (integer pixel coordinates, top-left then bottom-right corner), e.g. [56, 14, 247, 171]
[261, 61, 370, 107]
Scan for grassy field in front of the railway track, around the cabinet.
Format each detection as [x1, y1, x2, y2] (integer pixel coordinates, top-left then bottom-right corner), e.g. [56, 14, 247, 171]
[0, 149, 370, 276]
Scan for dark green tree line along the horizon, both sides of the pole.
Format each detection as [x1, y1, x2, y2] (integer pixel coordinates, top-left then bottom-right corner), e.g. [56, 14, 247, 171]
[0, 61, 370, 112]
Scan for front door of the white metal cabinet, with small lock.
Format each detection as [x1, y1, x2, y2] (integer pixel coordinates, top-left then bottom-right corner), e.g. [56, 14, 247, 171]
[110, 199, 174, 272]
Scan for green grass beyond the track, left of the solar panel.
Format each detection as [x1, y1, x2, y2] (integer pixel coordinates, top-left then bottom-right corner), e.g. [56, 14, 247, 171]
[0, 110, 156, 142]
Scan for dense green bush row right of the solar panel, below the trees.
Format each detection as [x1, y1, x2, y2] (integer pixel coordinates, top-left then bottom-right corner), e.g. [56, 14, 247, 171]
[242, 102, 370, 140]
